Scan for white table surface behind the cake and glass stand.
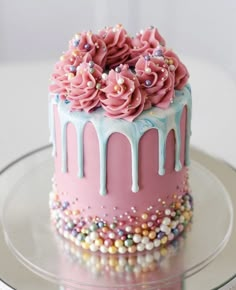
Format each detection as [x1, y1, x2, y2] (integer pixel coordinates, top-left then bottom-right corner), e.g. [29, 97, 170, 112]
[0, 56, 236, 168]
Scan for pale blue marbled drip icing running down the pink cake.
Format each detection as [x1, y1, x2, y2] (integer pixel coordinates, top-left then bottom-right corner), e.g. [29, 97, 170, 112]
[49, 85, 192, 195]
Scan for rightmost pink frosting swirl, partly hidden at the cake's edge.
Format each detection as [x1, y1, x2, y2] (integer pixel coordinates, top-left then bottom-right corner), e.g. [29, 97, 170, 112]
[163, 49, 189, 90]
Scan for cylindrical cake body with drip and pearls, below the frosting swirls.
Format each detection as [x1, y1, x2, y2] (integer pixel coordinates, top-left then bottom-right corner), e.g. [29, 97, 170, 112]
[51, 87, 192, 252]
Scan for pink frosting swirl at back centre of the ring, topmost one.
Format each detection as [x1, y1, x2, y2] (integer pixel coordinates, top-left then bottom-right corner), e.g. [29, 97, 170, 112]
[99, 25, 131, 67]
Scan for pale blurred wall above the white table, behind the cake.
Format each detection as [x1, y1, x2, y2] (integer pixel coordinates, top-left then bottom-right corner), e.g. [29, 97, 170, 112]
[0, 0, 236, 73]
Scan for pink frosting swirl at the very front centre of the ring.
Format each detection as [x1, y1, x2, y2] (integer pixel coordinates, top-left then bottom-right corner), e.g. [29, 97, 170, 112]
[100, 65, 145, 121]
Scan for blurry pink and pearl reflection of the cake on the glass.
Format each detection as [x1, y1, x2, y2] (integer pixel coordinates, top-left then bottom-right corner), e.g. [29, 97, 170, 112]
[54, 227, 190, 290]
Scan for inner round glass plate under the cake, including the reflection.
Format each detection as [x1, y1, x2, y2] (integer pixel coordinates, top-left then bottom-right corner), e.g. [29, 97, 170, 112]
[1, 146, 233, 290]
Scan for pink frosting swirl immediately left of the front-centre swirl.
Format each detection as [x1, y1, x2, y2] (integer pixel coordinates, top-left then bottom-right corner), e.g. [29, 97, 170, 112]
[67, 61, 103, 112]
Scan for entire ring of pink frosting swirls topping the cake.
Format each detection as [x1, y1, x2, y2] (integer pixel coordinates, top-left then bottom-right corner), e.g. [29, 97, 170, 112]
[49, 25, 189, 121]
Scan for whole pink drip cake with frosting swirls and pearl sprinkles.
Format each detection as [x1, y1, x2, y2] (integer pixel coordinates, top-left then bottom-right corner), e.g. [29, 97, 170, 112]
[49, 25, 193, 254]
